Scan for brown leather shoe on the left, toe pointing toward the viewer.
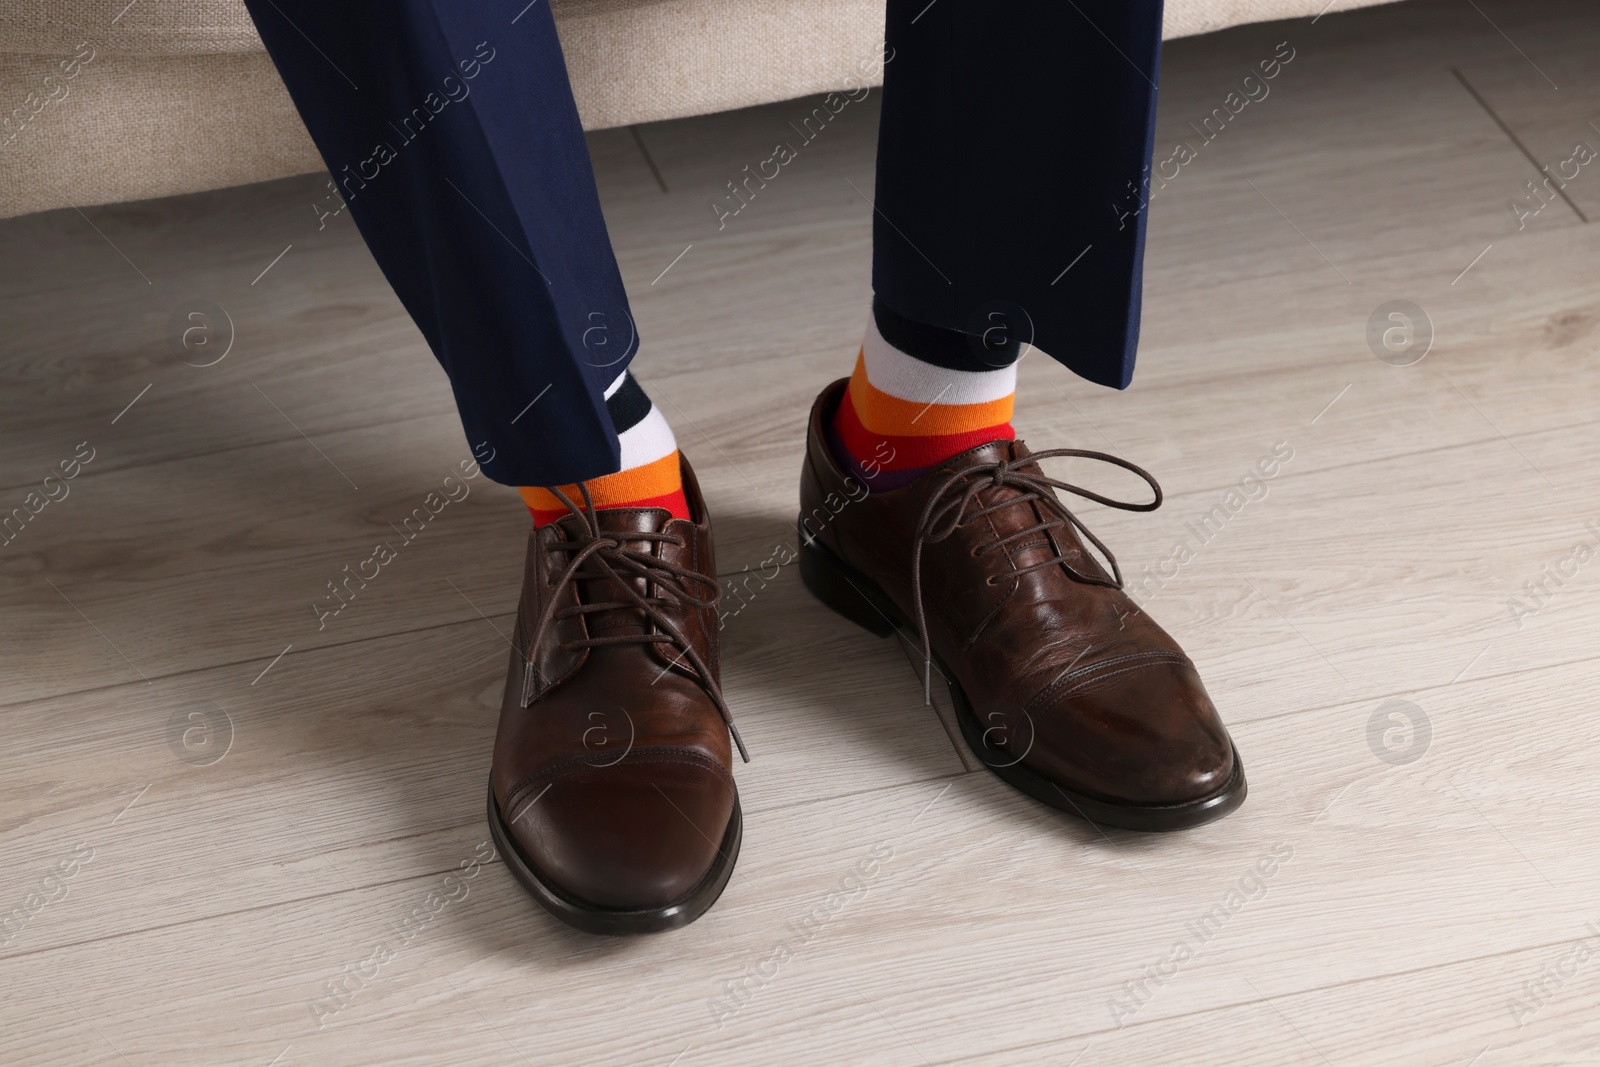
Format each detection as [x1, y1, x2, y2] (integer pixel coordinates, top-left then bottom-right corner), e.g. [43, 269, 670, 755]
[488, 461, 744, 934]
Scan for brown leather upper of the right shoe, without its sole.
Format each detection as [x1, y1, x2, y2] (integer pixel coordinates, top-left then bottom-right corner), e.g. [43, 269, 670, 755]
[800, 381, 1234, 805]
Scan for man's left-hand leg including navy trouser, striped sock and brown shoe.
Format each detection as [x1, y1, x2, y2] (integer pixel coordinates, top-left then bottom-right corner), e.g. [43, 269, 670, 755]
[246, 0, 741, 933]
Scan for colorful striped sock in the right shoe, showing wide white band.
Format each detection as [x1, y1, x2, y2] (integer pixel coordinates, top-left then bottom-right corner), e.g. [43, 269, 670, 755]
[829, 301, 1021, 490]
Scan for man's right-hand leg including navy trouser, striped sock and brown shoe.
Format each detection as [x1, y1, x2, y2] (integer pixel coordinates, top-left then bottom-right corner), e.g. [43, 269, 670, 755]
[800, 0, 1245, 830]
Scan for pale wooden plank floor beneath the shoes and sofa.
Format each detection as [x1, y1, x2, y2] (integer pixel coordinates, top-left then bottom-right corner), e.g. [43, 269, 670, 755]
[0, 0, 1600, 1067]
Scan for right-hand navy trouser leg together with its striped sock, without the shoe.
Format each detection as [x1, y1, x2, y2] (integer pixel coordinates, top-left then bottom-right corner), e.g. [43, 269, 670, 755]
[832, 0, 1162, 488]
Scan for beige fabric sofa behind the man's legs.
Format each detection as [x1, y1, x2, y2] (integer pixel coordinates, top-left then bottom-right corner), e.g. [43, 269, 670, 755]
[0, 0, 1384, 218]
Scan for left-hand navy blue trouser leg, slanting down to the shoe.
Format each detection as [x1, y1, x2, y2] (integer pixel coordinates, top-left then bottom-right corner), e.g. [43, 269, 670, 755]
[246, 0, 637, 485]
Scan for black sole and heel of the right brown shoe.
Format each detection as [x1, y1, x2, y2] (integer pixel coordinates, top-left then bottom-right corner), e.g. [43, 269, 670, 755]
[798, 517, 1250, 832]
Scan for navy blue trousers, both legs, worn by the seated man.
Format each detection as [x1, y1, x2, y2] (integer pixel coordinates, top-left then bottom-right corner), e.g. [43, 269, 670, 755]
[245, 0, 1162, 485]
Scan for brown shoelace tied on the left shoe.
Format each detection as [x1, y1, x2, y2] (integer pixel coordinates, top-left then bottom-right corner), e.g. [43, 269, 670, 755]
[528, 482, 750, 763]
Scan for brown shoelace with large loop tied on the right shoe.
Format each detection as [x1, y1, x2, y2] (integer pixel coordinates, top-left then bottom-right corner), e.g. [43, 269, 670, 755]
[910, 448, 1162, 704]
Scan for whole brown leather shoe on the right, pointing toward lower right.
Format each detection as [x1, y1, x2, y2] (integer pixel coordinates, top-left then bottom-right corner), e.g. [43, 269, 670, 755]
[800, 379, 1245, 830]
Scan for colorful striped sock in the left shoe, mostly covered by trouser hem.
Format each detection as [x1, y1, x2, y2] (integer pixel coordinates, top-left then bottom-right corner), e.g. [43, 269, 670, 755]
[518, 371, 690, 526]
